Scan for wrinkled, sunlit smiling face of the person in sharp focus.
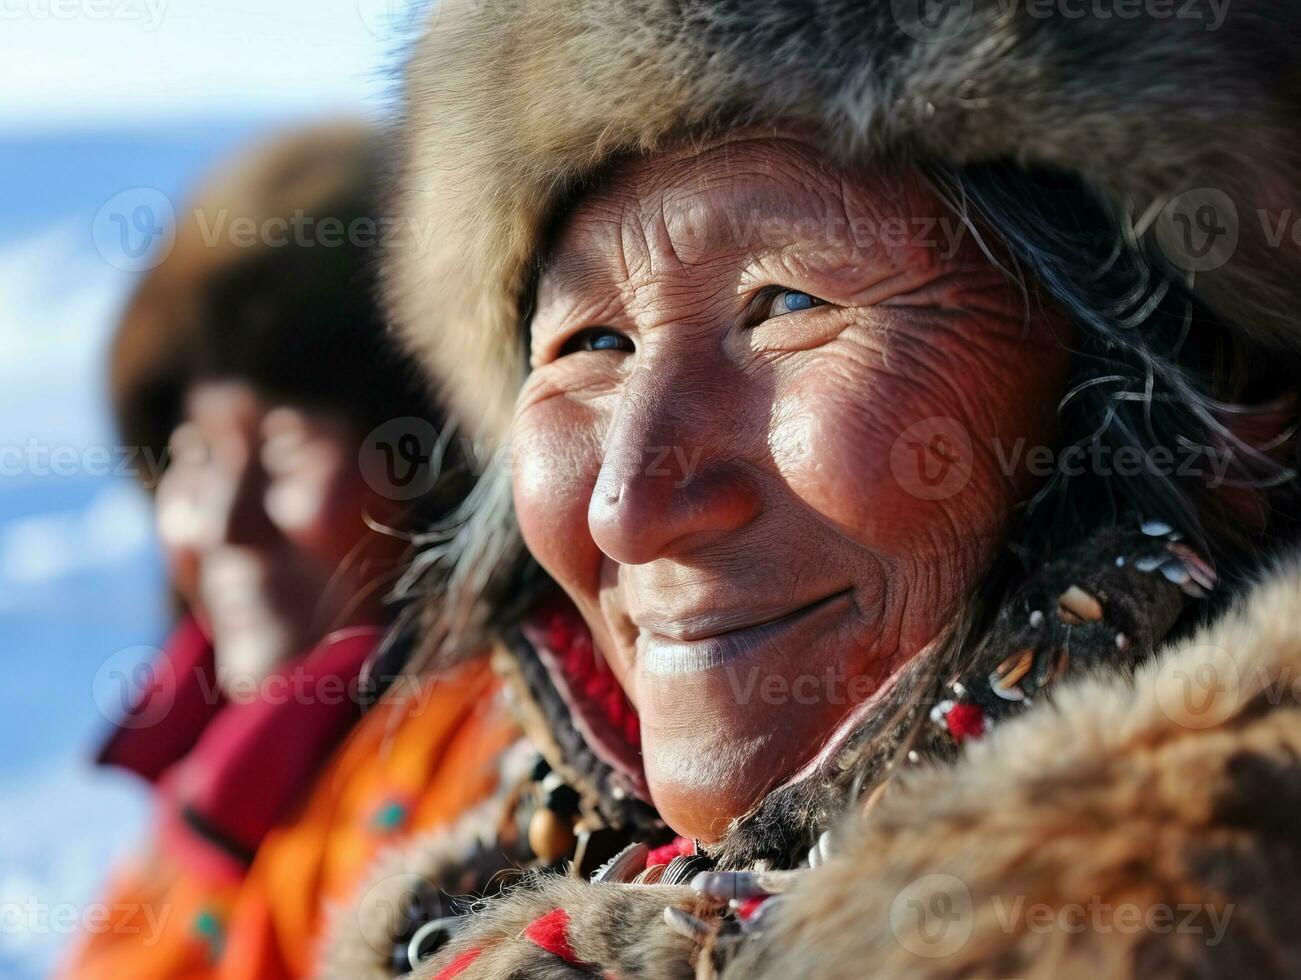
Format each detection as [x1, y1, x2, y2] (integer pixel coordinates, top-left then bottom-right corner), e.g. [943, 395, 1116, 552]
[513, 138, 1066, 839]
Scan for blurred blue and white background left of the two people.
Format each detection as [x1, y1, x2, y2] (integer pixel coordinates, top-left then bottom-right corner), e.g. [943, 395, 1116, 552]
[0, 0, 429, 980]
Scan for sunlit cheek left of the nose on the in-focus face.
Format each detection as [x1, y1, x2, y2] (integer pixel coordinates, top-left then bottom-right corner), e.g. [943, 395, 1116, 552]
[511, 397, 601, 601]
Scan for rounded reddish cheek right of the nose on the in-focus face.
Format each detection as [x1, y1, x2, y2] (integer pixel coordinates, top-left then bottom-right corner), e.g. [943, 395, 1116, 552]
[769, 326, 1064, 556]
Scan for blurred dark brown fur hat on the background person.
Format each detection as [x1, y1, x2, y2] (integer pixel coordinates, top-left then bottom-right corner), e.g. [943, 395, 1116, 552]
[111, 122, 433, 478]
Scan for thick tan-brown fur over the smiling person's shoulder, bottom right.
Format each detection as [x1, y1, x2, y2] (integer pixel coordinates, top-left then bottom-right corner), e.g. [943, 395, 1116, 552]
[727, 566, 1301, 979]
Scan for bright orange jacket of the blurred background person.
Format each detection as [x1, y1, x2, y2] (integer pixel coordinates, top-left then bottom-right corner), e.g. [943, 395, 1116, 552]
[62, 660, 519, 980]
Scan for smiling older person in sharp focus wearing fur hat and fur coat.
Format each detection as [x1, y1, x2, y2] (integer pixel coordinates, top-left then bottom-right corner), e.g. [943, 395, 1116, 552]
[336, 0, 1301, 980]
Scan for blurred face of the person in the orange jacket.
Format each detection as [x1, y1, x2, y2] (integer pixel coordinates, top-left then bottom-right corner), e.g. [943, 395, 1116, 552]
[156, 381, 384, 683]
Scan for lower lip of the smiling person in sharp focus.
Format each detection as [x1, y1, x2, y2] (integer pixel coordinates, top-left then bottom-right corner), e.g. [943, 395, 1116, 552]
[639, 591, 851, 677]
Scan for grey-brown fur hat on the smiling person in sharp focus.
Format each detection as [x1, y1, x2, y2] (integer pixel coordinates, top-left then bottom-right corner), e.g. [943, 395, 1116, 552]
[388, 0, 1301, 440]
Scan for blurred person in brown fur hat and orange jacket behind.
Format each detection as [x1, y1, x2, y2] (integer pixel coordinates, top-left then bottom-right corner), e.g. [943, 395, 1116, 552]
[64, 122, 515, 980]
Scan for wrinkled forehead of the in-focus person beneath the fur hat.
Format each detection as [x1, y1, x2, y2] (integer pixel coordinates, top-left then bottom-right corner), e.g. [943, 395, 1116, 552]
[544, 138, 957, 325]
